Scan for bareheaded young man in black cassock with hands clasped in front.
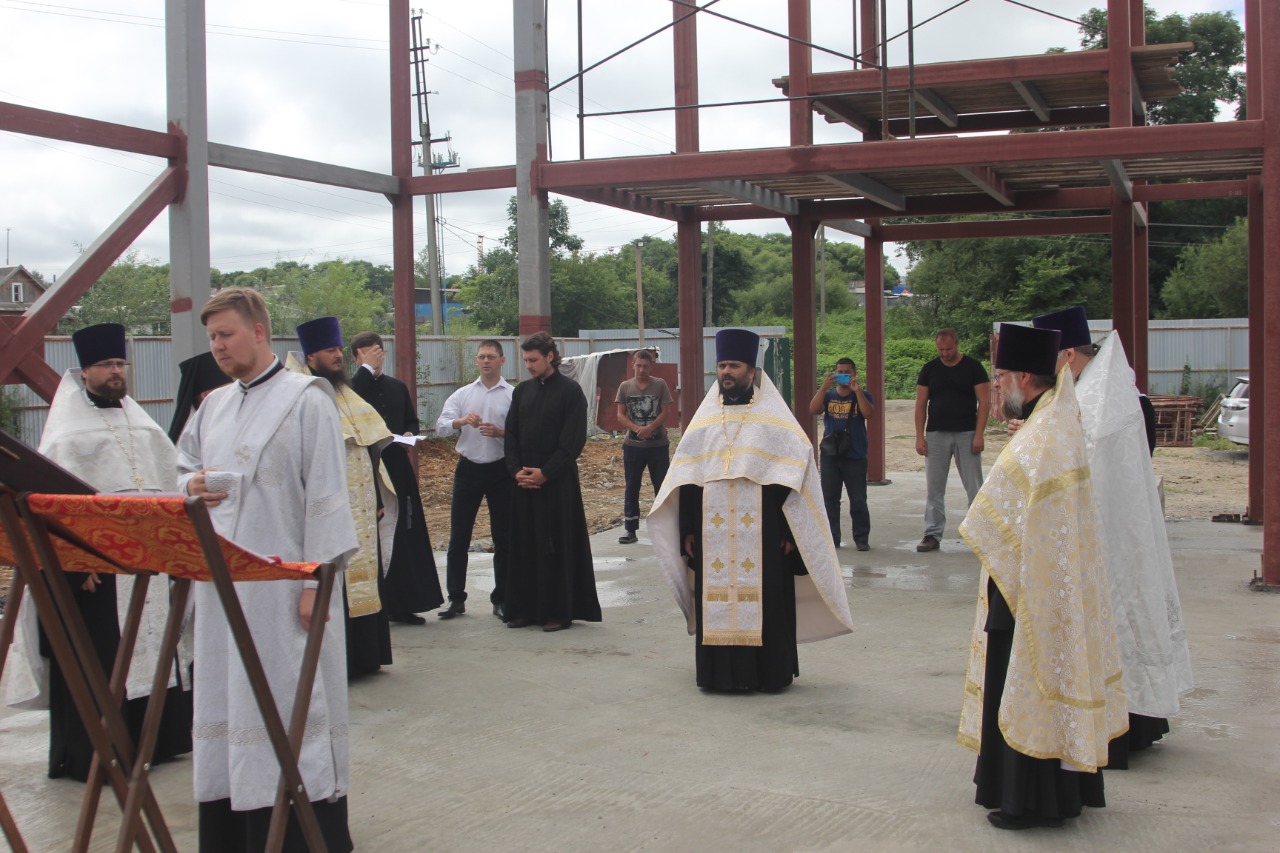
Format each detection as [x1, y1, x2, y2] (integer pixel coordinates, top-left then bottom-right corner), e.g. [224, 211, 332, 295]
[503, 332, 600, 631]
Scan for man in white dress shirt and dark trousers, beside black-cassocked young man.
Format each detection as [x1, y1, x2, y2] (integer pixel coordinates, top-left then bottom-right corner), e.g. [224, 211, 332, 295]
[435, 341, 516, 620]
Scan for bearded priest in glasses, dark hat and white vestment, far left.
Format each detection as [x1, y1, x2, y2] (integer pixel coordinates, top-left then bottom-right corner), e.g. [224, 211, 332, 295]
[5, 323, 191, 781]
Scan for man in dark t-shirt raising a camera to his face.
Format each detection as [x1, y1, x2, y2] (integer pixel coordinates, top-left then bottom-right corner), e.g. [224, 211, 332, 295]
[809, 359, 876, 551]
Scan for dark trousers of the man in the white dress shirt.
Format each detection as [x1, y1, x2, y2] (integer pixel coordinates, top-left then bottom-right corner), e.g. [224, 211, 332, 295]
[444, 456, 516, 605]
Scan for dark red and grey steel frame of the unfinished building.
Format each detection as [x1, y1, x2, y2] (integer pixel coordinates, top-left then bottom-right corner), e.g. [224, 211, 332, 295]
[0, 0, 1280, 585]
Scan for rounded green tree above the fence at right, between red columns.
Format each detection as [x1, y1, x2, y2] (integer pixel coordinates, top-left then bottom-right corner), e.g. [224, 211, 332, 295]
[1164, 219, 1249, 319]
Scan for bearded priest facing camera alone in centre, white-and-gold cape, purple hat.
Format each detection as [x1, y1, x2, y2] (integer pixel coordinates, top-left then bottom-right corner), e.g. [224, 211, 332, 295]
[648, 329, 852, 692]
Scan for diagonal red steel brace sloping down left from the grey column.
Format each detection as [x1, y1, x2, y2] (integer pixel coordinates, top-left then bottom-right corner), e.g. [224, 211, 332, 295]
[0, 167, 182, 377]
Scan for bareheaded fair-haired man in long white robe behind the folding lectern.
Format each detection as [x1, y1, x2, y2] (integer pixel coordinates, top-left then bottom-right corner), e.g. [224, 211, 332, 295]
[178, 288, 357, 853]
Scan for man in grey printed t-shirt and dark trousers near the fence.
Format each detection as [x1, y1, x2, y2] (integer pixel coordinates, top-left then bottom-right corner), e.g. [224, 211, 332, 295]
[614, 350, 676, 544]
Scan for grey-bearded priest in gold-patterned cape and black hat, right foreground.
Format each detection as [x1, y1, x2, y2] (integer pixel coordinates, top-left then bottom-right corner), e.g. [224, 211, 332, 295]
[959, 323, 1128, 830]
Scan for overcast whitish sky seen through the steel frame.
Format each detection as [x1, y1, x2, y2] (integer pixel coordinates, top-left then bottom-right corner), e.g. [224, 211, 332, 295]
[0, 0, 1244, 285]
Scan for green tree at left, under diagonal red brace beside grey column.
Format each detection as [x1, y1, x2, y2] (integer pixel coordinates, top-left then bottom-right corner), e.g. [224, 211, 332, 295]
[74, 248, 170, 334]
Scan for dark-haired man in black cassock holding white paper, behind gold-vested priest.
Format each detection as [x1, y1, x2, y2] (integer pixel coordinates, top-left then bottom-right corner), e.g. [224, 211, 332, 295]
[351, 332, 444, 625]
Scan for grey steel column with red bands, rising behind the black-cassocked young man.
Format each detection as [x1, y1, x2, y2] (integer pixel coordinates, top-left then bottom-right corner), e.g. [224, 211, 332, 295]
[515, 0, 552, 337]
